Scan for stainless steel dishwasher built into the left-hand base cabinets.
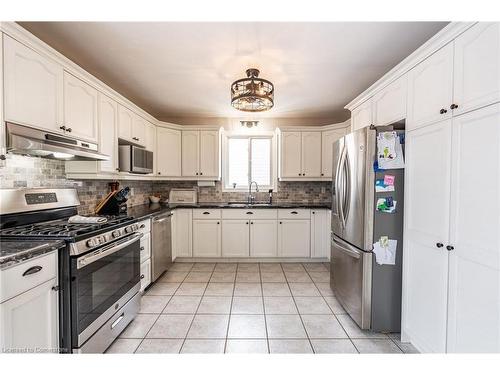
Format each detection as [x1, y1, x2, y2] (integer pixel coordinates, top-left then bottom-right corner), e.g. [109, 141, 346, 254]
[151, 212, 172, 281]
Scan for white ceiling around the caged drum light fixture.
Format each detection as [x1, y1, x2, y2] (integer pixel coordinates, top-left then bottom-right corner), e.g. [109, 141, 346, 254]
[20, 22, 446, 123]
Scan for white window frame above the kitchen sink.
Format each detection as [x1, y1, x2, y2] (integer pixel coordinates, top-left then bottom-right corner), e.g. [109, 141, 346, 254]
[222, 131, 278, 193]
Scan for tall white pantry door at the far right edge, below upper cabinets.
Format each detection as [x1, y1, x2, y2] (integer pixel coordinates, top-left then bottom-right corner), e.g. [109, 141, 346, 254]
[448, 104, 500, 353]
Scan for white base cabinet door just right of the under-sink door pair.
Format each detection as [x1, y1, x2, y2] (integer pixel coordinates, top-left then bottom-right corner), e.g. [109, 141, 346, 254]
[278, 220, 311, 258]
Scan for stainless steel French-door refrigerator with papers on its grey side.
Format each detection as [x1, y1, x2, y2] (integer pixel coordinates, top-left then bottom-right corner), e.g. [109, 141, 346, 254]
[331, 128, 404, 332]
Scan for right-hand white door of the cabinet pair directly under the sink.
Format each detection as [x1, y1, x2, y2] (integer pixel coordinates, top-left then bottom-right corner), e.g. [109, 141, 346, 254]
[250, 220, 278, 257]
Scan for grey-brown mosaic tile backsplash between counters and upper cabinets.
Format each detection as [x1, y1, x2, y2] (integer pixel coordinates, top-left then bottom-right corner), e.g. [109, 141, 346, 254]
[0, 154, 331, 214]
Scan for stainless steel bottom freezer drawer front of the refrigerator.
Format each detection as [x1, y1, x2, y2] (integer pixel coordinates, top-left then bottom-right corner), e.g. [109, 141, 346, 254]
[330, 235, 372, 329]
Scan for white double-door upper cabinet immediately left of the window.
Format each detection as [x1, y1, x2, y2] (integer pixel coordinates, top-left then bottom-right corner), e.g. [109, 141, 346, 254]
[182, 130, 220, 179]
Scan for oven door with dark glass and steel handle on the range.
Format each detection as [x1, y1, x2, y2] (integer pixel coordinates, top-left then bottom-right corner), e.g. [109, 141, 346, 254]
[71, 234, 142, 347]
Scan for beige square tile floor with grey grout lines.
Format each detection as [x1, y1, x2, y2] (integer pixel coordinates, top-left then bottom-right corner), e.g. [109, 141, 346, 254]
[107, 263, 417, 354]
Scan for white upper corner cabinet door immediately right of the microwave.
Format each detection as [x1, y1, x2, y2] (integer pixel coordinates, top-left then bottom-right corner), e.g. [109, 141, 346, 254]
[156, 127, 182, 177]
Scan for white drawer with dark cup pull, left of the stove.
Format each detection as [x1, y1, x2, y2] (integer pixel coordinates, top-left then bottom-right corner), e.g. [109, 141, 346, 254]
[0, 251, 57, 302]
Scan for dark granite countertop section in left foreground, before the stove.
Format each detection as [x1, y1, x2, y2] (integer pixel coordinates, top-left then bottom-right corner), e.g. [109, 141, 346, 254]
[0, 240, 65, 270]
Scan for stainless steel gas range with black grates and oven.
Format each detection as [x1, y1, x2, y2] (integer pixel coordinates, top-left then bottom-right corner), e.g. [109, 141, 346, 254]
[0, 189, 142, 353]
